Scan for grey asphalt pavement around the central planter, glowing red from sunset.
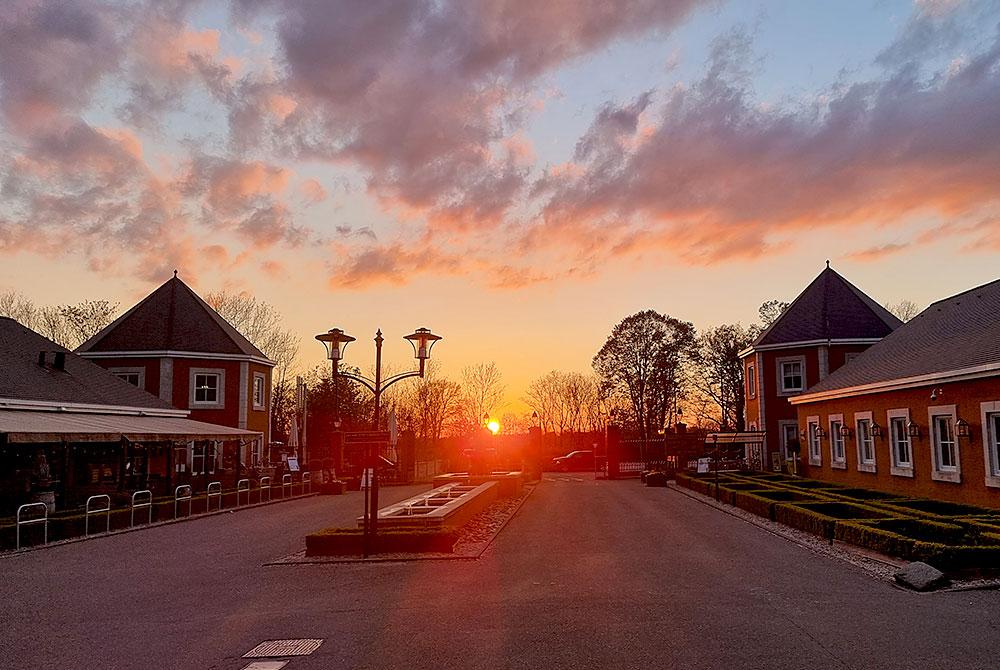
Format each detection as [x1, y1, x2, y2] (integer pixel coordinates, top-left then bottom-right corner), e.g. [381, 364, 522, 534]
[0, 475, 1000, 670]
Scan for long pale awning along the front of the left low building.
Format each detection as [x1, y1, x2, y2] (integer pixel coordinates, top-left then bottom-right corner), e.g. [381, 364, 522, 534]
[0, 410, 261, 444]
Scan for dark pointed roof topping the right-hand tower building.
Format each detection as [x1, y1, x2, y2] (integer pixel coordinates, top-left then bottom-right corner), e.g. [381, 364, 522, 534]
[753, 265, 902, 347]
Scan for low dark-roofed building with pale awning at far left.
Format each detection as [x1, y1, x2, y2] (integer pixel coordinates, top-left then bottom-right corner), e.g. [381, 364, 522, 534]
[0, 317, 261, 516]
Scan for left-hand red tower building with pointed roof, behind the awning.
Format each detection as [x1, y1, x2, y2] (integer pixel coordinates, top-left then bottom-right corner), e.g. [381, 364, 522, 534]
[77, 273, 274, 476]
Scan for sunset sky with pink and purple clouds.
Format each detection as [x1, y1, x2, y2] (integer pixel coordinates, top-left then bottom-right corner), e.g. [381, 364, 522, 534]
[0, 0, 1000, 412]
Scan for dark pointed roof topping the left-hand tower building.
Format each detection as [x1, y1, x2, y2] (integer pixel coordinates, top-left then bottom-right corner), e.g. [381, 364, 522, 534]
[77, 275, 267, 360]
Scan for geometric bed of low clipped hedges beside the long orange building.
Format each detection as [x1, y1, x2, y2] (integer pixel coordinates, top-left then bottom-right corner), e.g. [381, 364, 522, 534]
[676, 471, 1000, 573]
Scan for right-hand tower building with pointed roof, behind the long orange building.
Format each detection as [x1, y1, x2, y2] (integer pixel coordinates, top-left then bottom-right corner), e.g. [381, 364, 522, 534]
[740, 263, 901, 468]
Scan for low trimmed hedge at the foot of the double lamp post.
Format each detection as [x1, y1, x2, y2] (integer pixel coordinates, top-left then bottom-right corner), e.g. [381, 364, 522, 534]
[306, 528, 459, 556]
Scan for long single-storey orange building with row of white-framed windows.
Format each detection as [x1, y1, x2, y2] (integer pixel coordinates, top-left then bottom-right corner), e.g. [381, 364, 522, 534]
[791, 280, 1000, 507]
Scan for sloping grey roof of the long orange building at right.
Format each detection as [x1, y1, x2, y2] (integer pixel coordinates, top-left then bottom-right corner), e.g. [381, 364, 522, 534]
[805, 279, 1000, 396]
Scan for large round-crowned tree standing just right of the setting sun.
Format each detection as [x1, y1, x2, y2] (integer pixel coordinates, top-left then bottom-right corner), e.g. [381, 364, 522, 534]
[593, 310, 695, 439]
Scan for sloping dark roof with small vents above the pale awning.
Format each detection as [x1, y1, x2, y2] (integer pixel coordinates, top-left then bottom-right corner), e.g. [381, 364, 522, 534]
[0, 317, 177, 413]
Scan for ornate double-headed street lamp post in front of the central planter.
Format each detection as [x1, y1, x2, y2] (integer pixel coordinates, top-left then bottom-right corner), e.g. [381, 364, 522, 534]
[316, 328, 441, 558]
